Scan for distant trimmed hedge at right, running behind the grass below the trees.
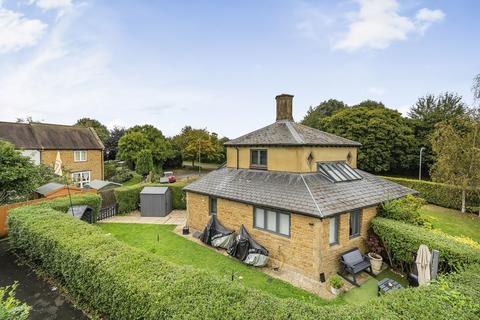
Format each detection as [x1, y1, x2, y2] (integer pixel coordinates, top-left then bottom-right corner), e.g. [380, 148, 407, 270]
[382, 177, 480, 212]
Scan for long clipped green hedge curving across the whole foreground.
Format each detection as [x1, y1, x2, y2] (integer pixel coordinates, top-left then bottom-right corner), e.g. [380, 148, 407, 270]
[8, 207, 480, 320]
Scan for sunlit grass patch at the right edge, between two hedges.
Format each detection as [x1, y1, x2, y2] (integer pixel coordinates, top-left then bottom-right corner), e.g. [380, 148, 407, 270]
[420, 204, 480, 243]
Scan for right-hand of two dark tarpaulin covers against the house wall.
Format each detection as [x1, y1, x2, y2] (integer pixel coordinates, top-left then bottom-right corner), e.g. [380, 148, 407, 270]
[228, 225, 268, 267]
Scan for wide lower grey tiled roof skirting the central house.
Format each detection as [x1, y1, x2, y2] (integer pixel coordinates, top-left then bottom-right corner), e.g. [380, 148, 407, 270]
[184, 168, 416, 217]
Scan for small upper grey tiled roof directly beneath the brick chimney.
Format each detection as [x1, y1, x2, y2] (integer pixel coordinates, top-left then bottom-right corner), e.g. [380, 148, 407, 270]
[225, 120, 361, 147]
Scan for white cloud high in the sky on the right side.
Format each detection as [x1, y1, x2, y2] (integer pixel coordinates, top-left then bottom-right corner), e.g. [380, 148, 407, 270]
[334, 0, 445, 52]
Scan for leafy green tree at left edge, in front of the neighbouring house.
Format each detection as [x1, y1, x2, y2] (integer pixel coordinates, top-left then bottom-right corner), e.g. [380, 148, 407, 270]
[0, 140, 54, 204]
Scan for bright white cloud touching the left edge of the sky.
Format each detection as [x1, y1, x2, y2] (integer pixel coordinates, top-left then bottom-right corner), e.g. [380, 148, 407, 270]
[0, 3, 47, 53]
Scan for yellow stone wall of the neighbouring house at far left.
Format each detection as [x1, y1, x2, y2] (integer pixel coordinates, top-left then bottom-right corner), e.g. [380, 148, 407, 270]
[40, 150, 103, 180]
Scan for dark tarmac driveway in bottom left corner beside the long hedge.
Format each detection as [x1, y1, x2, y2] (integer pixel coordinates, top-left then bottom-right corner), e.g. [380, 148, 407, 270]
[0, 240, 88, 320]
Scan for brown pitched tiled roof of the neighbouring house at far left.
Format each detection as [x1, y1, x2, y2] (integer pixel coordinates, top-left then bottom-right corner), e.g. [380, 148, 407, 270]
[0, 122, 103, 150]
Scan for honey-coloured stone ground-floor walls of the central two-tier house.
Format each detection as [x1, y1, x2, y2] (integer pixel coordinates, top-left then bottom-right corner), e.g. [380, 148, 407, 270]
[186, 192, 376, 281]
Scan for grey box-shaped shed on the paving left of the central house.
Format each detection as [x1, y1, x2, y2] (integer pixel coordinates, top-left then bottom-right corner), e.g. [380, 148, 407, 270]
[140, 187, 172, 217]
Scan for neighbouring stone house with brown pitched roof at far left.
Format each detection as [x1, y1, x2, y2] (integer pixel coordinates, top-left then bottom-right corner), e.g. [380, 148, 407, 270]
[0, 122, 104, 187]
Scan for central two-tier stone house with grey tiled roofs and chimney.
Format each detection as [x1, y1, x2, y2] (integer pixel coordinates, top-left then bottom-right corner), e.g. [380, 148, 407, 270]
[184, 94, 414, 281]
